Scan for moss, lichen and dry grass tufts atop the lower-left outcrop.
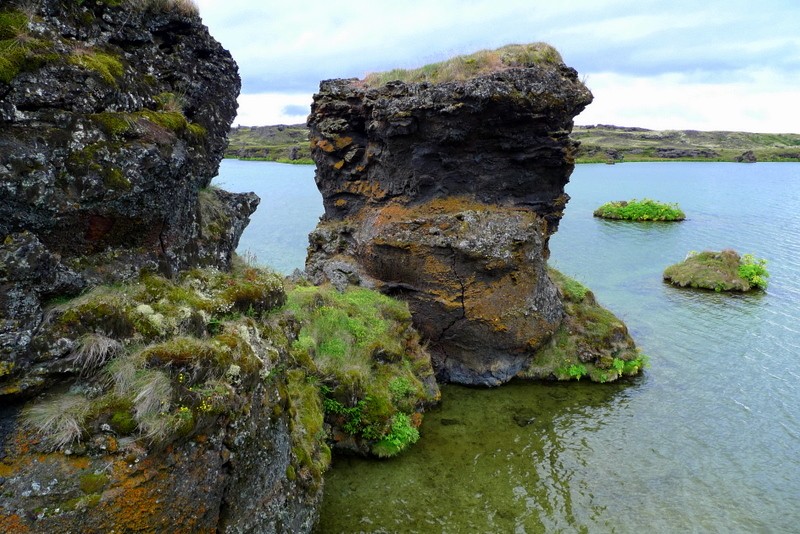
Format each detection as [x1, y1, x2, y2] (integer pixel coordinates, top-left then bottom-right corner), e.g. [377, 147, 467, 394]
[23, 267, 285, 449]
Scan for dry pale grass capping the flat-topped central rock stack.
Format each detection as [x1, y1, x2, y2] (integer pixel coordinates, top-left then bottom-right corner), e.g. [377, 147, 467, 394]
[363, 43, 562, 87]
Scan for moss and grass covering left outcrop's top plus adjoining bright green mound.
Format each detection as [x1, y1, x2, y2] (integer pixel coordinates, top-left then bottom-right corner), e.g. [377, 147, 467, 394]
[23, 262, 438, 468]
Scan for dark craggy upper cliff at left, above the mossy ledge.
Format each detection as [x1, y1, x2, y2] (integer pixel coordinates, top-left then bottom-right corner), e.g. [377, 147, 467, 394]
[0, 0, 258, 400]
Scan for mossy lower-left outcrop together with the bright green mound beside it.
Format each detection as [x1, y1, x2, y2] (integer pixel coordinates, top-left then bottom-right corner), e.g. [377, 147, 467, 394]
[0, 265, 439, 532]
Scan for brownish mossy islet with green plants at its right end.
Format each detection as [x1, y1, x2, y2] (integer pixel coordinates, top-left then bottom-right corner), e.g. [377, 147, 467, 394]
[664, 249, 769, 292]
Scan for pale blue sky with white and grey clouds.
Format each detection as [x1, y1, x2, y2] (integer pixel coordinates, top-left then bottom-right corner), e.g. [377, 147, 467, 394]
[196, 0, 800, 133]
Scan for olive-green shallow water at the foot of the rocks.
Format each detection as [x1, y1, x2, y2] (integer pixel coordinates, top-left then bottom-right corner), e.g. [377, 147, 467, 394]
[319, 379, 645, 532]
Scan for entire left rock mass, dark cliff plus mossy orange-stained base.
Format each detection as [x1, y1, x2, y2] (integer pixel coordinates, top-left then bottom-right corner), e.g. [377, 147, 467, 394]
[0, 0, 330, 532]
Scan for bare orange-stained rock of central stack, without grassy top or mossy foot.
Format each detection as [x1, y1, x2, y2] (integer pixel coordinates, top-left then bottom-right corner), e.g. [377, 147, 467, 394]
[306, 64, 591, 385]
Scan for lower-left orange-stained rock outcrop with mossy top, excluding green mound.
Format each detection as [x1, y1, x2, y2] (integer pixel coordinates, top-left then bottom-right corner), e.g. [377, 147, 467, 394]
[0, 267, 330, 532]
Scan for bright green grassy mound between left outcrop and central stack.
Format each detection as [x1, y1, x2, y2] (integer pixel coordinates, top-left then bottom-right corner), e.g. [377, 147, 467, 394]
[285, 286, 437, 456]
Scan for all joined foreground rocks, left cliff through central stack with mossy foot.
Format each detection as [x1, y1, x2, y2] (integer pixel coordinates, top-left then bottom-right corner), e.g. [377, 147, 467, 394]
[0, 0, 643, 532]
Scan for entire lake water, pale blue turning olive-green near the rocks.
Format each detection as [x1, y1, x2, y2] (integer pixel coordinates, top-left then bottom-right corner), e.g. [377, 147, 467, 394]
[220, 161, 800, 533]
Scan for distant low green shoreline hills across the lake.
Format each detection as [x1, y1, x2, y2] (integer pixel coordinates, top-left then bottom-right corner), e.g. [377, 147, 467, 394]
[225, 124, 800, 163]
